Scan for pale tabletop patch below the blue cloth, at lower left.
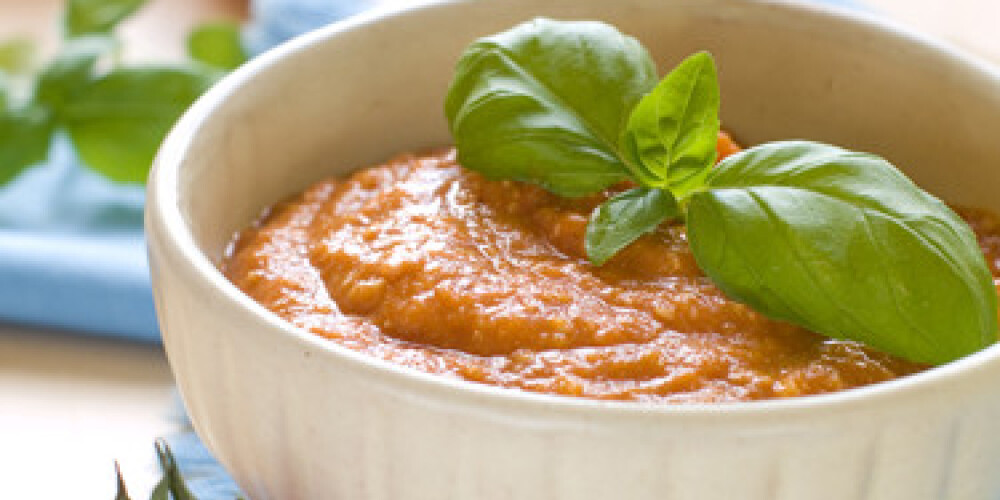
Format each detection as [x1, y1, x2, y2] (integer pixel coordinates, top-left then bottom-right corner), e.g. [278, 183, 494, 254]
[0, 326, 180, 500]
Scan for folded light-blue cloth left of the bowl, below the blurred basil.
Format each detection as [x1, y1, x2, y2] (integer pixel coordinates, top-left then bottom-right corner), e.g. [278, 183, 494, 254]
[0, 138, 159, 342]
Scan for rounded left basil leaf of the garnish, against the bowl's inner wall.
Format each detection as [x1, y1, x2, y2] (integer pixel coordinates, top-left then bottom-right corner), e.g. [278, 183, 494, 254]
[445, 19, 657, 196]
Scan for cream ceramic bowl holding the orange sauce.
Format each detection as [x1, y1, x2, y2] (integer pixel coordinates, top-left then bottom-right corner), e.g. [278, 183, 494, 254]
[147, 0, 1000, 500]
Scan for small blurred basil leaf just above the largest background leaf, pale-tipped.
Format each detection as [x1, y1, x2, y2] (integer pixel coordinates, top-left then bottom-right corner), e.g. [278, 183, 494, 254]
[35, 35, 115, 113]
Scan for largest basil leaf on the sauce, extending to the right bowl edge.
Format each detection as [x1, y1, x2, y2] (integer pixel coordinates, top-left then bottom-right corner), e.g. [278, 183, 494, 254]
[687, 141, 997, 363]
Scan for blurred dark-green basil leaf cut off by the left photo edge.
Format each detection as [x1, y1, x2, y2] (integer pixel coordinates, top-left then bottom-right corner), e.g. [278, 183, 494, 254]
[0, 107, 53, 186]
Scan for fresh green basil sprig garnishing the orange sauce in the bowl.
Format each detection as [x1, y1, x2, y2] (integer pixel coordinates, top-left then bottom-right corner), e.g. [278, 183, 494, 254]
[445, 19, 998, 364]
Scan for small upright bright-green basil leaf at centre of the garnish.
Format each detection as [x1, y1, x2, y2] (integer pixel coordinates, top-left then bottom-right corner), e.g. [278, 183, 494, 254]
[621, 52, 720, 198]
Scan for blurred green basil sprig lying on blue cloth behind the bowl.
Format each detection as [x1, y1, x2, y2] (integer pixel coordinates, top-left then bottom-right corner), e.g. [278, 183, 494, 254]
[0, 0, 246, 186]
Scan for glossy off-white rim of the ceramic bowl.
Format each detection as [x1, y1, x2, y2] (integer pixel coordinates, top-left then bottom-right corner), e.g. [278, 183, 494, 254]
[146, 0, 1000, 421]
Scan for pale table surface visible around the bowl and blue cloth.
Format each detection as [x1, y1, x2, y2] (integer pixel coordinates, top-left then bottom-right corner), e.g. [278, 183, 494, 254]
[0, 0, 1000, 500]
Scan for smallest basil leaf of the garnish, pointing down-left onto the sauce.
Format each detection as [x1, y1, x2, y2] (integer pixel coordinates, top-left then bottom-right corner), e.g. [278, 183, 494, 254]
[584, 187, 678, 266]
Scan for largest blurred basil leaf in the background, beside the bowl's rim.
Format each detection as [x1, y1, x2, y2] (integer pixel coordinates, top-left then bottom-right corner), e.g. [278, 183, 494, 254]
[62, 68, 213, 183]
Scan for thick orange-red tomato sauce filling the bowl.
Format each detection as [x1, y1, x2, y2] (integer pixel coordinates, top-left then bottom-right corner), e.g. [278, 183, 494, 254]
[223, 137, 1000, 403]
